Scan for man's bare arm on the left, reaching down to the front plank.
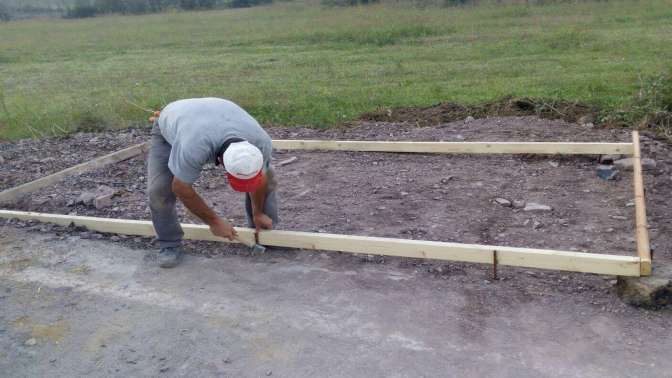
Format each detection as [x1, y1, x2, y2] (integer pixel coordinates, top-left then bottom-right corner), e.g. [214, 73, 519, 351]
[172, 177, 238, 240]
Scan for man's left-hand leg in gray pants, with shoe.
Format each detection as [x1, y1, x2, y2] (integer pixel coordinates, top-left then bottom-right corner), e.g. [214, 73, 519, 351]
[147, 123, 184, 268]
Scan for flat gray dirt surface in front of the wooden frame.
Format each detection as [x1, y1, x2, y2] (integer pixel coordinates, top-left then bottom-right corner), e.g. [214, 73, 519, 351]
[0, 226, 672, 378]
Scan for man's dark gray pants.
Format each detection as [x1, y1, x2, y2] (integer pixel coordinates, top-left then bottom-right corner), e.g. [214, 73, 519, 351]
[147, 123, 278, 248]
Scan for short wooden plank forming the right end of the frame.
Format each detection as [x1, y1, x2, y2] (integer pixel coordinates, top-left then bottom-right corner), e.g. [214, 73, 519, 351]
[632, 131, 651, 276]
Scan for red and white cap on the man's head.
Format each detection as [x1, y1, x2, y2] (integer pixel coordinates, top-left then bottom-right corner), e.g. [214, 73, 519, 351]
[222, 141, 264, 192]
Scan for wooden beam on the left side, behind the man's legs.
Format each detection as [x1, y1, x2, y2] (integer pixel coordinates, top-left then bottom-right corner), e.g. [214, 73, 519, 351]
[0, 143, 148, 204]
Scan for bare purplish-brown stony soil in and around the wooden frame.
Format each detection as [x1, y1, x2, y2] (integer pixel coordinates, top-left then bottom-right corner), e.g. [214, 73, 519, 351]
[0, 117, 672, 309]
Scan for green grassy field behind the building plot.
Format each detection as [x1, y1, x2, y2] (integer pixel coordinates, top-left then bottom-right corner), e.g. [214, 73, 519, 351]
[0, 0, 672, 140]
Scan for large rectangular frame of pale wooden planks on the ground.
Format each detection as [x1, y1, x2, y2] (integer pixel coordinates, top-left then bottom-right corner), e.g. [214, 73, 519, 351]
[0, 131, 651, 276]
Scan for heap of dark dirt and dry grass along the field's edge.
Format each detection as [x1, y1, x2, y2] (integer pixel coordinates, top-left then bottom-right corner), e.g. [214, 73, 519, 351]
[360, 97, 598, 126]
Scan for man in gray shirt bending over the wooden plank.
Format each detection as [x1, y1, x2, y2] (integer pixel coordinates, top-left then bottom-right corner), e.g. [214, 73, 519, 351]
[147, 98, 278, 268]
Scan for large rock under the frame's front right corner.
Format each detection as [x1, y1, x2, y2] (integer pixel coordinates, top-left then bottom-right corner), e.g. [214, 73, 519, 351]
[616, 261, 672, 309]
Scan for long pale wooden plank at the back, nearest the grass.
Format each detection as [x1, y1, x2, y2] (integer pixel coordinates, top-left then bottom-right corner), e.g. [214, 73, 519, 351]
[273, 140, 633, 155]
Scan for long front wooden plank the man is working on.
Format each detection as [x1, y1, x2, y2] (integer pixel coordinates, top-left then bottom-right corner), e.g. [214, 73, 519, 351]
[0, 210, 640, 276]
